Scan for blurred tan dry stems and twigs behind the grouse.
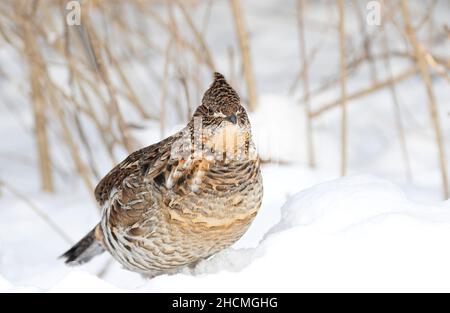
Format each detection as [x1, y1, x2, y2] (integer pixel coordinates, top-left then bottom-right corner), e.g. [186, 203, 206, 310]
[0, 0, 450, 198]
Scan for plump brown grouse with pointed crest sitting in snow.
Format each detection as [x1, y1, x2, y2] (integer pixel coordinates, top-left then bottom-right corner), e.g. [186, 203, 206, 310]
[61, 72, 263, 278]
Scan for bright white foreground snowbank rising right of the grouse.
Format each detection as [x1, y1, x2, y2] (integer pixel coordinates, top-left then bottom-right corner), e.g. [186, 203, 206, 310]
[0, 175, 450, 292]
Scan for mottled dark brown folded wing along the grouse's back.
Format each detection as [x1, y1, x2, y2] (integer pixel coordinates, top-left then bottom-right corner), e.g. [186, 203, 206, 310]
[95, 134, 180, 205]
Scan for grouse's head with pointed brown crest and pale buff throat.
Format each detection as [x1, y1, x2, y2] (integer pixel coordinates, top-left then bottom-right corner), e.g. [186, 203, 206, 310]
[193, 73, 251, 161]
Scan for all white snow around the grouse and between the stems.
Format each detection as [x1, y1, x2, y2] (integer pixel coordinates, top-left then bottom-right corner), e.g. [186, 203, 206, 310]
[0, 0, 450, 292]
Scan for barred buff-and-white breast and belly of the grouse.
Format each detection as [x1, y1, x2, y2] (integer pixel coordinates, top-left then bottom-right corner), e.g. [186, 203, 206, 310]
[101, 151, 262, 276]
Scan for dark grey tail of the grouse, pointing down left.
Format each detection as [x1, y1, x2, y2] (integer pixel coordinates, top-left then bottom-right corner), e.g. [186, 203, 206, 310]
[60, 225, 105, 265]
